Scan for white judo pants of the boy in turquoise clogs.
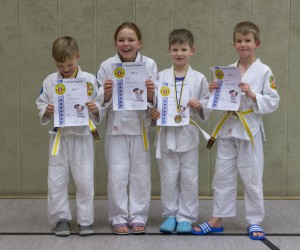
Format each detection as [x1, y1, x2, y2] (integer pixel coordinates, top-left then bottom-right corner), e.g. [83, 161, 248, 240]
[157, 147, 199, 223]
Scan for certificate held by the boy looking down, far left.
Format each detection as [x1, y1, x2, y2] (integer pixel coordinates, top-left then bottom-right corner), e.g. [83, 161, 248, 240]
[53, 78, 89, 127]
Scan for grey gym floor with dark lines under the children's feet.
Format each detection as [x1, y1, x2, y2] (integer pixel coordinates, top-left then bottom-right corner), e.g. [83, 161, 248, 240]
[0, 199, 300, 250]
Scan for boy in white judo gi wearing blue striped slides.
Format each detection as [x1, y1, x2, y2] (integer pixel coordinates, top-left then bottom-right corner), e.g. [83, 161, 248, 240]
[192, 22, 279, 240]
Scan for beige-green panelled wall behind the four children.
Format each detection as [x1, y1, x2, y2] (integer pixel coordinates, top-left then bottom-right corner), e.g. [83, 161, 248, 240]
[0, 0, 300, 196]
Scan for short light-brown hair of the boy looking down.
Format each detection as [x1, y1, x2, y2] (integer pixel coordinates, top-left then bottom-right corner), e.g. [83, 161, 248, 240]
[52, 36, 79, 63]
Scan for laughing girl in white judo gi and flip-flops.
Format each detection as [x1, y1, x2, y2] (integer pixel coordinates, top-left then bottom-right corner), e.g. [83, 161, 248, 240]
[97, 22, 158, 234]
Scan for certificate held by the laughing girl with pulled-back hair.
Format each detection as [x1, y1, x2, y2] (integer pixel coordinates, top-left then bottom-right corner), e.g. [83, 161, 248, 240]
[112, 62, 147, 110]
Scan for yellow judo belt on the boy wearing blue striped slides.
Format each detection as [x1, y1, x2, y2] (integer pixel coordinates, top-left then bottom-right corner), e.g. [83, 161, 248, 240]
[206, 109, 253, 149]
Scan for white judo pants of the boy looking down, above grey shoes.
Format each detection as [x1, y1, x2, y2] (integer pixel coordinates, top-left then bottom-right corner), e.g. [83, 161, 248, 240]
[48, 135, 94, 226]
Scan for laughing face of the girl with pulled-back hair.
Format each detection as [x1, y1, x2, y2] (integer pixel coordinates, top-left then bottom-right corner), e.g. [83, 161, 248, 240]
[116, 28, 142, 62]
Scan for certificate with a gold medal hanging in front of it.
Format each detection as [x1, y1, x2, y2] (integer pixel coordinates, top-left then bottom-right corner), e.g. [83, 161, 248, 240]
[157, 81, 190, 126]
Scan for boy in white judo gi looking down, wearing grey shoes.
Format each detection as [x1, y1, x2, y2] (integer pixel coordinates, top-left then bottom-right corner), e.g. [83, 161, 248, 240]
[36, 36, 100, 236]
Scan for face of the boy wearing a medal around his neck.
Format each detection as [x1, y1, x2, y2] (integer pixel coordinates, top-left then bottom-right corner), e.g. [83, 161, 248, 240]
[169, 43, 195, 67]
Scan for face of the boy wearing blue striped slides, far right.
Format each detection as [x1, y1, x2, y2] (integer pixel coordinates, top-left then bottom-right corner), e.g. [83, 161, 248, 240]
[234, 33, 260, 59]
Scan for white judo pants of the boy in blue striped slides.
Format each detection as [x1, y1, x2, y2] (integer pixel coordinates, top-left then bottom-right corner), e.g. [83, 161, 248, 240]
[212, 131, 265, 225]
